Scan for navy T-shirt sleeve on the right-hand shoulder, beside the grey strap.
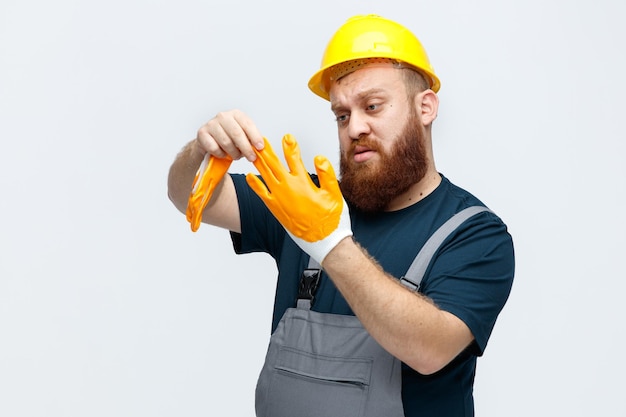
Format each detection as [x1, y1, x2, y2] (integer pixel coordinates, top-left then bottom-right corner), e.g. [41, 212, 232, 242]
[422, 213, 515, 356]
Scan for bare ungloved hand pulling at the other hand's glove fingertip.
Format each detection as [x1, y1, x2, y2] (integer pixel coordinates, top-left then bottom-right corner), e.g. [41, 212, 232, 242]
[197, 110, 264, 162]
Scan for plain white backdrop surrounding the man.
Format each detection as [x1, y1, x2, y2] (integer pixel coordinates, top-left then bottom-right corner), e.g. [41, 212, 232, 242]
[0, 0, 626, 417]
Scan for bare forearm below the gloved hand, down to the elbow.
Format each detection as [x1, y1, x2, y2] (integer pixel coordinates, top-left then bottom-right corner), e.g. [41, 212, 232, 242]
[323, 238, 473, 374]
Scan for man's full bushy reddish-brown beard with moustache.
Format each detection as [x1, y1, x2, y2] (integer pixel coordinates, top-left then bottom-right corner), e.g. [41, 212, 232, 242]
[339, 109, 428, 212]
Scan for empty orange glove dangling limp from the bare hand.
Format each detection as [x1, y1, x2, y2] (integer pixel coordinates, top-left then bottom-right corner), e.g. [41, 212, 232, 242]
[187, 154, 233, 232]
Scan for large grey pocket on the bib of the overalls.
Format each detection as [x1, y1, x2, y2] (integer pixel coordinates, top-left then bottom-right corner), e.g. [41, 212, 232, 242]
[262, 347, 372, 417]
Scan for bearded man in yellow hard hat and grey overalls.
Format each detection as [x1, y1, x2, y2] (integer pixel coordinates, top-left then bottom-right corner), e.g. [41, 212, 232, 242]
[169, 15, 514, 416]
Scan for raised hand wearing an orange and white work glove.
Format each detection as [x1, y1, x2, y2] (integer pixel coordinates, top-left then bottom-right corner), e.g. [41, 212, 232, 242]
[246, 135, 352, 265]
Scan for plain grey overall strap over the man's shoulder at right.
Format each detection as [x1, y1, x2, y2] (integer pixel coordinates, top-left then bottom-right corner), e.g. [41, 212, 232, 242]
[400, 206, 491, 291]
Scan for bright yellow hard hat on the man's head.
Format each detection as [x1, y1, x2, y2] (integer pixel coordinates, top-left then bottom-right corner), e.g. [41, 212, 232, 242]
[309, 14, 440, 100]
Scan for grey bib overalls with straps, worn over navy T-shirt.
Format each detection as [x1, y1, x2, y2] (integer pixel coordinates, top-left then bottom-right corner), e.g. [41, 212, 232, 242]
[255, 206, 488, 417]
